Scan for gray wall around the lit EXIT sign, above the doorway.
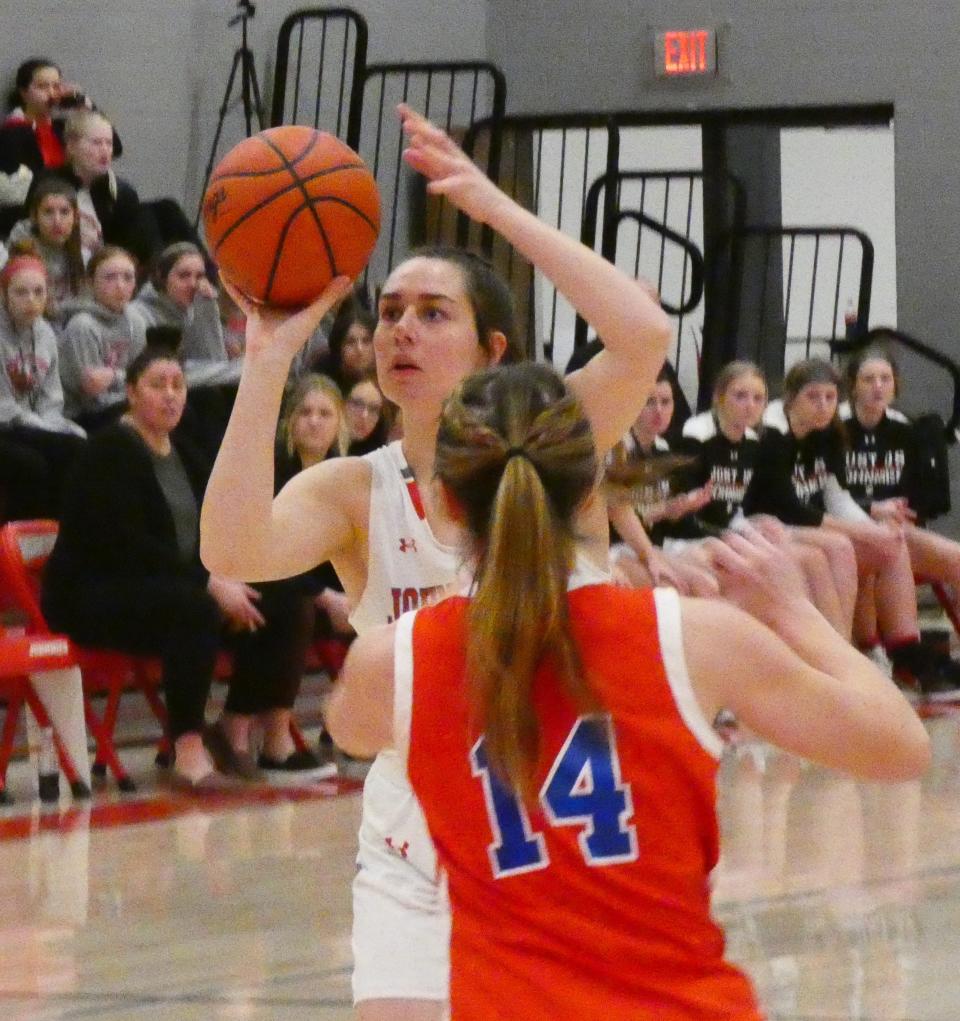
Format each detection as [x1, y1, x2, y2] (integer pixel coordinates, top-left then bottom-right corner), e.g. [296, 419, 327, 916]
[487, 0, 960, 355]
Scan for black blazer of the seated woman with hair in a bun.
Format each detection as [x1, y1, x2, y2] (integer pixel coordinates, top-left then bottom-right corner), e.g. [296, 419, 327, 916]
[43, 423, 209, 627]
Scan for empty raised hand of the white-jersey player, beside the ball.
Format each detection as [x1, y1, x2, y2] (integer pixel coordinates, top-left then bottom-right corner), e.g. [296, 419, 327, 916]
[396, 103, 509, 224]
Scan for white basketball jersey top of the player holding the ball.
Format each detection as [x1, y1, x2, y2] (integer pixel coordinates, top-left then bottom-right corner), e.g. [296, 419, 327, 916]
[350, 440, 461, 634]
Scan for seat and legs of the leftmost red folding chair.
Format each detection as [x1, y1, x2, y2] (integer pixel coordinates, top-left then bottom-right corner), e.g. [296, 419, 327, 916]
[0, 628, 90, 805]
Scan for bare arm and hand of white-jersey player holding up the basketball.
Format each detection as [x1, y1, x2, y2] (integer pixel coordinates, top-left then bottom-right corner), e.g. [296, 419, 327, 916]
[200, 277, 355, 581]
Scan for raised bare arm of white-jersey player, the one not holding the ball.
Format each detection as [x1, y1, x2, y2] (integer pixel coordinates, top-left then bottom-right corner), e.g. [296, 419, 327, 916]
[398, 104, 671, 454]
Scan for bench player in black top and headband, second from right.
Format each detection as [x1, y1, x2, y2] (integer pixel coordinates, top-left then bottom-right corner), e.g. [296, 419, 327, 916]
[743, 358, 960, 697]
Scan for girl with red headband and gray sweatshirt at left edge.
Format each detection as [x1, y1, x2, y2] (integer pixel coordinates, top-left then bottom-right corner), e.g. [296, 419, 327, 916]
[0, 248, 85, 518]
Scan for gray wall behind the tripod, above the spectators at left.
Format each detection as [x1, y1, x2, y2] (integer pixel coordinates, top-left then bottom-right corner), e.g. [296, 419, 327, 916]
[0, 0, 486, 215]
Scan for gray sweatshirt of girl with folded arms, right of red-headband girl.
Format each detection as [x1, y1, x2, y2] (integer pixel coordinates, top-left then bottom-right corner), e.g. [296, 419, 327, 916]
[60, 298, 147, 416]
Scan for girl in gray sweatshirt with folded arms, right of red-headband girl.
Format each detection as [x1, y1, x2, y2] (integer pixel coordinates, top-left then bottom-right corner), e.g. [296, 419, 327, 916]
[60, 245, 146, 432]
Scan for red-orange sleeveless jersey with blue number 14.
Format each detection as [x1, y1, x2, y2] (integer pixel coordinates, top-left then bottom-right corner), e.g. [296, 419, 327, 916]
[396, 585, 761, 1021]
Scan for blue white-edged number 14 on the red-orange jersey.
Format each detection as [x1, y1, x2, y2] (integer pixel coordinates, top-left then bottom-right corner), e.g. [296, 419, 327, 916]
[470, 716, 637, 879]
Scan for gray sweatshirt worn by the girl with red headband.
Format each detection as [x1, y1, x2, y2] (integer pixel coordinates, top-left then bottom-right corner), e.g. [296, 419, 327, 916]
[0, 308, 87, 436]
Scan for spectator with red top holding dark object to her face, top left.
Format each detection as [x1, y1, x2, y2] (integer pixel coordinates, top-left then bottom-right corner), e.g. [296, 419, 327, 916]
[0, 57, 123, 237]
